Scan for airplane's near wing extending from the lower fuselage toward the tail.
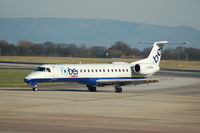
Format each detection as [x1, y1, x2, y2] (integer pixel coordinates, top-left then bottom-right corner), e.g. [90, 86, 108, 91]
[96, 78, 169, 85]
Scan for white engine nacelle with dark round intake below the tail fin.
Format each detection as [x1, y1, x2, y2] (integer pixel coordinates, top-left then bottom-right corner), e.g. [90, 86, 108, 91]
[131, 64, 160, 75]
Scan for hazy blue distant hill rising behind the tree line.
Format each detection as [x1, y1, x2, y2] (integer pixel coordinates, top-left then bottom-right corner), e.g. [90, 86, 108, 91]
[0, 18, 200, 48]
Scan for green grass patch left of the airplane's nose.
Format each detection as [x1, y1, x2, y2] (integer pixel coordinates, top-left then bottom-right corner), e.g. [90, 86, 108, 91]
[0, 69, 31, 87]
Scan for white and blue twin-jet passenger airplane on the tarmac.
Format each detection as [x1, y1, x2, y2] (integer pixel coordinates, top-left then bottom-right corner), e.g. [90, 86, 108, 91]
[24, 41, 183, 93]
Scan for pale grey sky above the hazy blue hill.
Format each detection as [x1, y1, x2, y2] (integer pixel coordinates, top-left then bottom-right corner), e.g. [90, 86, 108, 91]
[0, 0, 200, 29]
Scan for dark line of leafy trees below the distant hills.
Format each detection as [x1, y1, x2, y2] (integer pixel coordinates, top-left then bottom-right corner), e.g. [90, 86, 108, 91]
[0, 40, 200, 60]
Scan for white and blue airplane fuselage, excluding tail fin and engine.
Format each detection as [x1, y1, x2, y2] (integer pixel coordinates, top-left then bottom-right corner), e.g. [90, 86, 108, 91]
[25, 63, 157, 85]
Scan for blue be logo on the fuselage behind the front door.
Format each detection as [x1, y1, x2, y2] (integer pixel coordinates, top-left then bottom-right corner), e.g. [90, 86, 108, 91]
[60, 67, 78, 78]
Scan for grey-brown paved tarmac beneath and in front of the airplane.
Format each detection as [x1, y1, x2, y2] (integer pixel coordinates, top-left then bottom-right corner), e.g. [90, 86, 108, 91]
[0, 61, 200, 133]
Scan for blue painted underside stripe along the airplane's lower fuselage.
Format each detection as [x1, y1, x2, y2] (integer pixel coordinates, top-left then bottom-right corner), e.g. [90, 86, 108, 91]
[24, 77, 144, 85]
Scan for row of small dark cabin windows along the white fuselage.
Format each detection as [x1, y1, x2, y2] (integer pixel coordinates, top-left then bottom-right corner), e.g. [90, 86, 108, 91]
[80, 69, 128, 73]
